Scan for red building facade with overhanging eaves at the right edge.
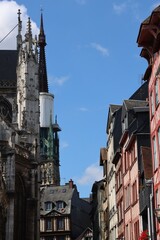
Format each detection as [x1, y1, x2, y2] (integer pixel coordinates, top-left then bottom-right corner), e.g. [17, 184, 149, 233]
[137, 6, 160, 240]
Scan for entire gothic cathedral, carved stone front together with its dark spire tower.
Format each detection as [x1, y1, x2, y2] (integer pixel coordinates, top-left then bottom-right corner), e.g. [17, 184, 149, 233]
[0, 10, 60, 240]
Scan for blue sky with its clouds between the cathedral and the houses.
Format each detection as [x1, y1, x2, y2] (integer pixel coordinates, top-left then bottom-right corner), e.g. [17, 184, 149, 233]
[0, 0, 160, 197]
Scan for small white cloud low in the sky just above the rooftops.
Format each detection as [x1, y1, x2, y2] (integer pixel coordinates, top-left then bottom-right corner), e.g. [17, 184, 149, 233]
[77, 164, 102, 185]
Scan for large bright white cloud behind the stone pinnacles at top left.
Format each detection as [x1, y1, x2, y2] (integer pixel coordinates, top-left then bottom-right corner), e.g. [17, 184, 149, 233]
[0, 0, 39, 49]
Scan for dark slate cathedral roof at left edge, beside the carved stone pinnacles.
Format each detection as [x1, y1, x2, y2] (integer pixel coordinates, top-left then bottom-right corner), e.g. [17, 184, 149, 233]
[0, 50, 18, 88]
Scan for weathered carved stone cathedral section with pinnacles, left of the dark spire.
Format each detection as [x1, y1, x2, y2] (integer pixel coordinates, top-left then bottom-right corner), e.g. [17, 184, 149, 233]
[0, 11, 40, 240]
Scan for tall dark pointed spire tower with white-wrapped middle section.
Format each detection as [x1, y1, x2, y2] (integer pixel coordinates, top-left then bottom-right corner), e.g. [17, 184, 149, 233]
[38, 14, 61, 186]
